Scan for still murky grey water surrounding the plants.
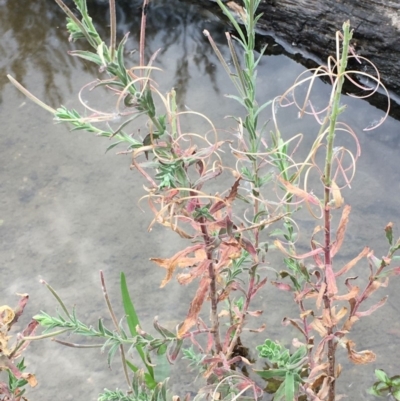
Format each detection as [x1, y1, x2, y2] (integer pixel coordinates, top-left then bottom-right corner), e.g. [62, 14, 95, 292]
[0, 0, 400, 400]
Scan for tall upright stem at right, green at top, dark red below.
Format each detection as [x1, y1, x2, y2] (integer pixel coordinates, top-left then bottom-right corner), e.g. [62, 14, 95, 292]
[323, 22, 351, 401]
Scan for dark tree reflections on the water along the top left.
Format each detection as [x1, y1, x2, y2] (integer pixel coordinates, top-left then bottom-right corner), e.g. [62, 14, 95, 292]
[0, 0, 225, 106]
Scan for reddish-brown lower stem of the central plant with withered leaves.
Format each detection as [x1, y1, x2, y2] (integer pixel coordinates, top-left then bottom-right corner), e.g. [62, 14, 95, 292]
[199, 217, 222, 354]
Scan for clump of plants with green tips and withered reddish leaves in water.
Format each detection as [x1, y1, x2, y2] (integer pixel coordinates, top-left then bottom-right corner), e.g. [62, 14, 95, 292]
[0, 0, 400, 401]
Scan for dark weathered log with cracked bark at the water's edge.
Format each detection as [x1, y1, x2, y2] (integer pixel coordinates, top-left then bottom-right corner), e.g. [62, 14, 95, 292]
[255, 0, 400, 95]
